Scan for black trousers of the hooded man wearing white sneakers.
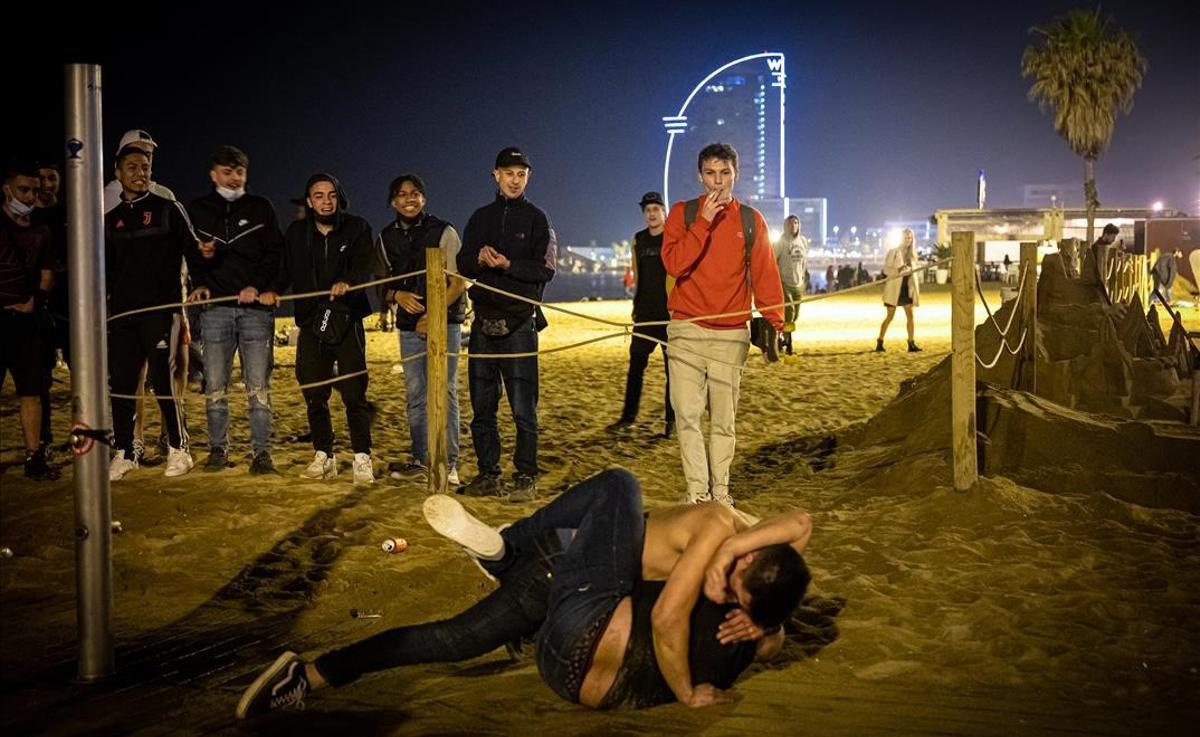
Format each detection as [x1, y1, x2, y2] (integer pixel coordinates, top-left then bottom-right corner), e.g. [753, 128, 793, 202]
[296, 319, 371, 455]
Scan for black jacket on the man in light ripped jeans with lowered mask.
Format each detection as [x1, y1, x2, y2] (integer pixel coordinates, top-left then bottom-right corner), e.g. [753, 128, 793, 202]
[187, 192, 283, 308]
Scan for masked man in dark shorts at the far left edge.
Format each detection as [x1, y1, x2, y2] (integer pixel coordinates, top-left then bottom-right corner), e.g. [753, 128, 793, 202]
[0, 166, 59, 481]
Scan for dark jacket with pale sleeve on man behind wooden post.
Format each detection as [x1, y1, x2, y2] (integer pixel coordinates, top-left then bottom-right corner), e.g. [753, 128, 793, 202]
[376, 212, 467, 331]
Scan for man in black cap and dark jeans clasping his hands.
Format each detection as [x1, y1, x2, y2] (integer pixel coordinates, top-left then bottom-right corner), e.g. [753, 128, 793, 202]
[458, 148, 558, 502]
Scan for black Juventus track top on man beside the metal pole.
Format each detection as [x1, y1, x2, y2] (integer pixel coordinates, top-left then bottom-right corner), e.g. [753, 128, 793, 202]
[104, 192, 199, 314]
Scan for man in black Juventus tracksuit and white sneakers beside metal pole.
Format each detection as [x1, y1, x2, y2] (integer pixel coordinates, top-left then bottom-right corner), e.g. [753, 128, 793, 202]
[104, 145, 199, 481]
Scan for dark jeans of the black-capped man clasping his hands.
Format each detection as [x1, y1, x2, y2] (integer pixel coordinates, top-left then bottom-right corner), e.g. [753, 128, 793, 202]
[468, 318, 538, 475]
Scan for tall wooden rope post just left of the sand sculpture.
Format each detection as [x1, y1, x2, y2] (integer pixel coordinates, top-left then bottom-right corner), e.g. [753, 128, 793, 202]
[950, 232, 979, 491]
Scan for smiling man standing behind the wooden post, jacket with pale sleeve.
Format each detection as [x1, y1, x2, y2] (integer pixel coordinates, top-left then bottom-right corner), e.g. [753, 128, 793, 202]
[376, 174, 467, 486]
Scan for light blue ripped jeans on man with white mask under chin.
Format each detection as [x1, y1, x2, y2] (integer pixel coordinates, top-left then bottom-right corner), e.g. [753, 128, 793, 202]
[200, 305, 275, 454]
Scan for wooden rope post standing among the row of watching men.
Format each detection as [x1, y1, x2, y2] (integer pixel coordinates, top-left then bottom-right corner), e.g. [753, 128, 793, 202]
[425, 246, 456, 493]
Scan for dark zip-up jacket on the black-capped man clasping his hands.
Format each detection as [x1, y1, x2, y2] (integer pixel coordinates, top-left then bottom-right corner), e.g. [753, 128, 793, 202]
[458, 193, 558, 322]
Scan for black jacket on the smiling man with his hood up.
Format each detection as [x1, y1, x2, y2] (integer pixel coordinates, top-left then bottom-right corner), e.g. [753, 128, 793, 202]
[268, 212, 372, 326]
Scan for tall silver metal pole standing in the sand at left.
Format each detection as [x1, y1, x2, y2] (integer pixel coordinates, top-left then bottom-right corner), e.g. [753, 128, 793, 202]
[66, 64, 114, 681]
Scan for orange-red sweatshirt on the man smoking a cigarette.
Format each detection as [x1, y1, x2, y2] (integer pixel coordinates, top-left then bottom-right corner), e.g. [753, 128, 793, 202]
[662, 199, 784, 330]
